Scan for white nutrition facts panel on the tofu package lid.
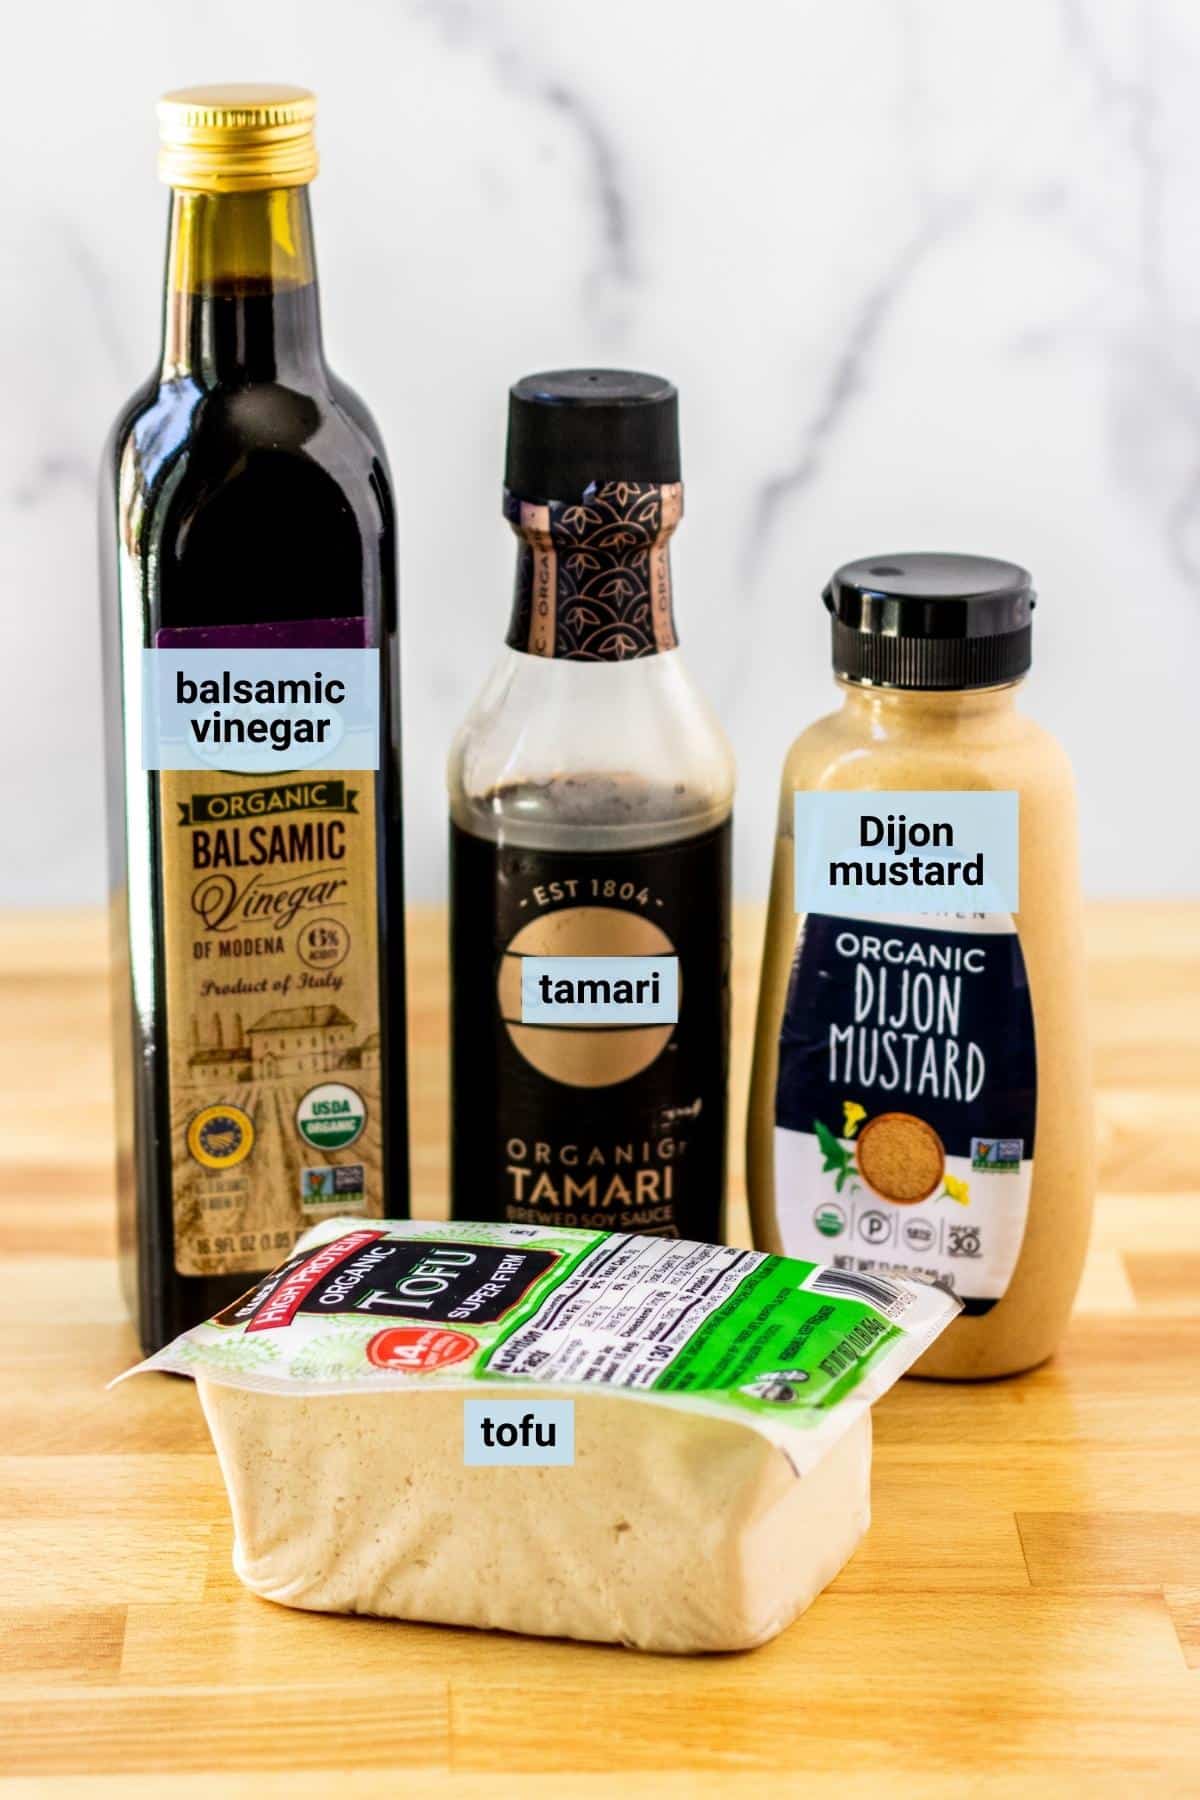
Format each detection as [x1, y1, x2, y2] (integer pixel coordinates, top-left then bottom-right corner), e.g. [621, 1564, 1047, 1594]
[488, 1237, 766, 1388]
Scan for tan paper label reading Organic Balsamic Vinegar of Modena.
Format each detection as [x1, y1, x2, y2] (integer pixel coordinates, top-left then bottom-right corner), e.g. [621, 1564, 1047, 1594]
[158, 770, 383, 1276]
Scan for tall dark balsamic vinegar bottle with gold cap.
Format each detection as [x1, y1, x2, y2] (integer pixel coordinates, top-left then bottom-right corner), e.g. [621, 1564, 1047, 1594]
[101, 86, 408, 1350]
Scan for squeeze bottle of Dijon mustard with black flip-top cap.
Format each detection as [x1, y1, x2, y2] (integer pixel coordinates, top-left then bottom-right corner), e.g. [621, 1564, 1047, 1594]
[748, 554, 1094, 1379]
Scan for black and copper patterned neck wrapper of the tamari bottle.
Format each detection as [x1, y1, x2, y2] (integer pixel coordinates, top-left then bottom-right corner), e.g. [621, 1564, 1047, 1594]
[504, 481, 684, 662]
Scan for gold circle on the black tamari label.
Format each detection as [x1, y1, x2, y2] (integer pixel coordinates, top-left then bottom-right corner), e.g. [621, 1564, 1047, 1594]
[497, 905, 682, 1087]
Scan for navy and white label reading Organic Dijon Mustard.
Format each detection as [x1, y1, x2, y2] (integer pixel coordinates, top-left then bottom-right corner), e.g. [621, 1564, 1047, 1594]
[775, 913, 1038, 1314]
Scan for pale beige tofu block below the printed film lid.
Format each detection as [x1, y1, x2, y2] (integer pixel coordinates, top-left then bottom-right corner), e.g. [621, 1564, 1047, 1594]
[198, 1375, 871, 1652]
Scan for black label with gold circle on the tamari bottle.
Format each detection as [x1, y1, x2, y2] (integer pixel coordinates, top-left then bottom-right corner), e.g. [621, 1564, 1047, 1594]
[452, 824, 730, 1242]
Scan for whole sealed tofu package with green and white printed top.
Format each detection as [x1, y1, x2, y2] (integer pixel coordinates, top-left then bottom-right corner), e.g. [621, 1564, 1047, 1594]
[130, 1219, 959, 1652]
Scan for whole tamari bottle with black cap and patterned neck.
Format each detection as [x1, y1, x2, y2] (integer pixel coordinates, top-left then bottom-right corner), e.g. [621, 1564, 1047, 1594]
[448, 369, 734, 1240]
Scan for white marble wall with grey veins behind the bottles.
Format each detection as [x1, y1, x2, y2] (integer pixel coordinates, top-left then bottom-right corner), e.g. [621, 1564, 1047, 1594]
[0, 0, 1200, 902]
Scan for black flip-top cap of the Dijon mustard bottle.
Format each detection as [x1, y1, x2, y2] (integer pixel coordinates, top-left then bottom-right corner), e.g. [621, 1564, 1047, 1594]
[824, 551, 1036, 688]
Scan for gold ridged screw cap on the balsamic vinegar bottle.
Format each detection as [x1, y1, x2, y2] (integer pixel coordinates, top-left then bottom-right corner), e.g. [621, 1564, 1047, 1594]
[158, 81, 317, 194]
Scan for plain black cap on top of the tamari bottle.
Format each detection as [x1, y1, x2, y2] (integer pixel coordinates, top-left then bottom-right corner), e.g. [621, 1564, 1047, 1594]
[504, 369, 680, 500]
